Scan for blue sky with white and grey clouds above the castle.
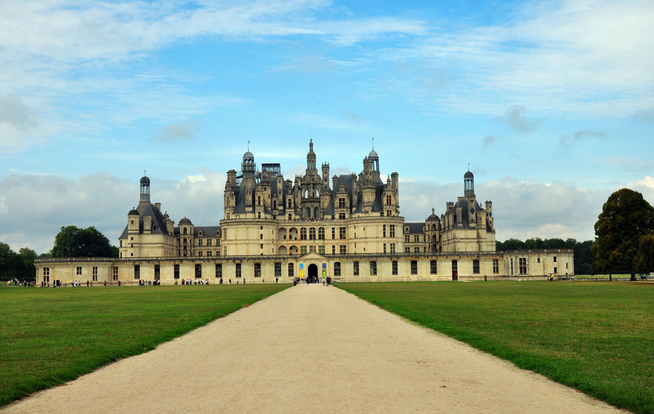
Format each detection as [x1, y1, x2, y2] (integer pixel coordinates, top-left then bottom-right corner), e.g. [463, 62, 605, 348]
[0, 0, 654, 253]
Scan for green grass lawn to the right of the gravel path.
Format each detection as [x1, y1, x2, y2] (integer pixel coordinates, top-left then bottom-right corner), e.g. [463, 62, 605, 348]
[338, 282, 654, 413]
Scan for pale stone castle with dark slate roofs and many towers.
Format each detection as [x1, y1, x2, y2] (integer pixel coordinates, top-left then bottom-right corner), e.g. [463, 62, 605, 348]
[36, 141, 574, 284]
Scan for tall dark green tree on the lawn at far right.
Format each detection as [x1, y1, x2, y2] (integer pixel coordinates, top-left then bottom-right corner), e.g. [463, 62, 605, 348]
[592, 188, 654, 280]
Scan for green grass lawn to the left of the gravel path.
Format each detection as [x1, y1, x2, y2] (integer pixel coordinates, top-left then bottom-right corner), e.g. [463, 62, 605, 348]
[0, 285, 289, 406]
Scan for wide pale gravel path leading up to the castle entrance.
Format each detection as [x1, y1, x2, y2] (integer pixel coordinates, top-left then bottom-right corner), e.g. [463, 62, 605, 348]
[2, 285, 622, 414]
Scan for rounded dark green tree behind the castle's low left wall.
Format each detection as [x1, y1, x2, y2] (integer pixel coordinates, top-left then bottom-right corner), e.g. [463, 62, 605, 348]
[50, 226, 118, 257]
